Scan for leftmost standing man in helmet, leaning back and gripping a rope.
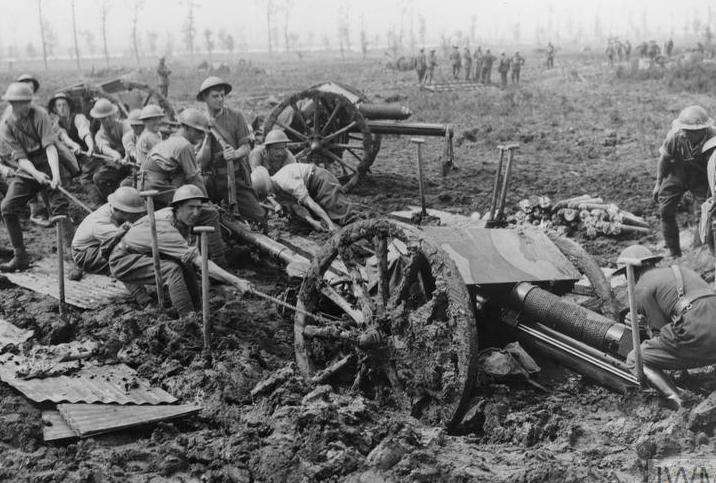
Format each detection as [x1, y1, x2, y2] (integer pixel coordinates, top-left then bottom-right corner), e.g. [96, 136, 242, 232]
[0, 82, 74, 272]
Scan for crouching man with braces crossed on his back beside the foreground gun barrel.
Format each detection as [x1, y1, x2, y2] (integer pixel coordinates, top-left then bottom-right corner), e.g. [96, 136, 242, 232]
[615, 245, 716, 402]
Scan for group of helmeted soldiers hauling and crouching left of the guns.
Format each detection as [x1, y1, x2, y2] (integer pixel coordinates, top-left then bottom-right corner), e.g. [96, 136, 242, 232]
[0, 71, 354, 315]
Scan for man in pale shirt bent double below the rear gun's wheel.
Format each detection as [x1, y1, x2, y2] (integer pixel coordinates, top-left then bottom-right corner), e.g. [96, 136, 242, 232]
[251, 163, 354, 231]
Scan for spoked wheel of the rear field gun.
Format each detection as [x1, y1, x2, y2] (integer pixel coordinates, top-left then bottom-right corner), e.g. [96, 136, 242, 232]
[264, 89, 377, 190]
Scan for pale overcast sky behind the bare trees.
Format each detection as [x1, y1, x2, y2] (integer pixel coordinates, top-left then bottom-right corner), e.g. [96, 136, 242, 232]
[0, 0, 716, 55]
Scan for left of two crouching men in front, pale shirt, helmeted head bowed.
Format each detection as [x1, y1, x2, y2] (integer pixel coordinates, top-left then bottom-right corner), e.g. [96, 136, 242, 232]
[70, 186, 147, 288]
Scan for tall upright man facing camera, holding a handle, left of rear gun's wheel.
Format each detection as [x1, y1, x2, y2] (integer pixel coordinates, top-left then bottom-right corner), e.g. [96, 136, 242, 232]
[196, 77, 266, 226]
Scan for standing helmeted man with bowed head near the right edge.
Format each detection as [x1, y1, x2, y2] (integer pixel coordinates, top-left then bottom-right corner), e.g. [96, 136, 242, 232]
[652, 106, 716, 258]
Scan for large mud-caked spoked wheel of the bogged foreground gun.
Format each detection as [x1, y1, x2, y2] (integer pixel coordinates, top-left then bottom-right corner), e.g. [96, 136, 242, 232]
[294, 220, 477, 427]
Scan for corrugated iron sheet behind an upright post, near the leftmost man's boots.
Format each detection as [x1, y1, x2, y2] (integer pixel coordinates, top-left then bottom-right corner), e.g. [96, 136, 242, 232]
[3, 258, 129, 309]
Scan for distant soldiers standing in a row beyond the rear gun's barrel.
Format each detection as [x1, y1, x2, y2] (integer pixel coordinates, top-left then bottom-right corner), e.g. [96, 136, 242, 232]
[416, 46, 525, 87]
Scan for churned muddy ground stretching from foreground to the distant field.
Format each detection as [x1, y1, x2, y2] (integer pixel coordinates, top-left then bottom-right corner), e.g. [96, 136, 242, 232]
[0, 55, 716, 481]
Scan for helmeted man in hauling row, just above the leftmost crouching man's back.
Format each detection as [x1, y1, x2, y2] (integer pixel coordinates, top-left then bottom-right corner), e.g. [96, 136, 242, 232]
[90, 99, 138, 204]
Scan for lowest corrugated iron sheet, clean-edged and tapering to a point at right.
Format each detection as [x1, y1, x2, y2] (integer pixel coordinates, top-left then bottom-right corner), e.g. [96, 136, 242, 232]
[57, 404, 201, 438]
